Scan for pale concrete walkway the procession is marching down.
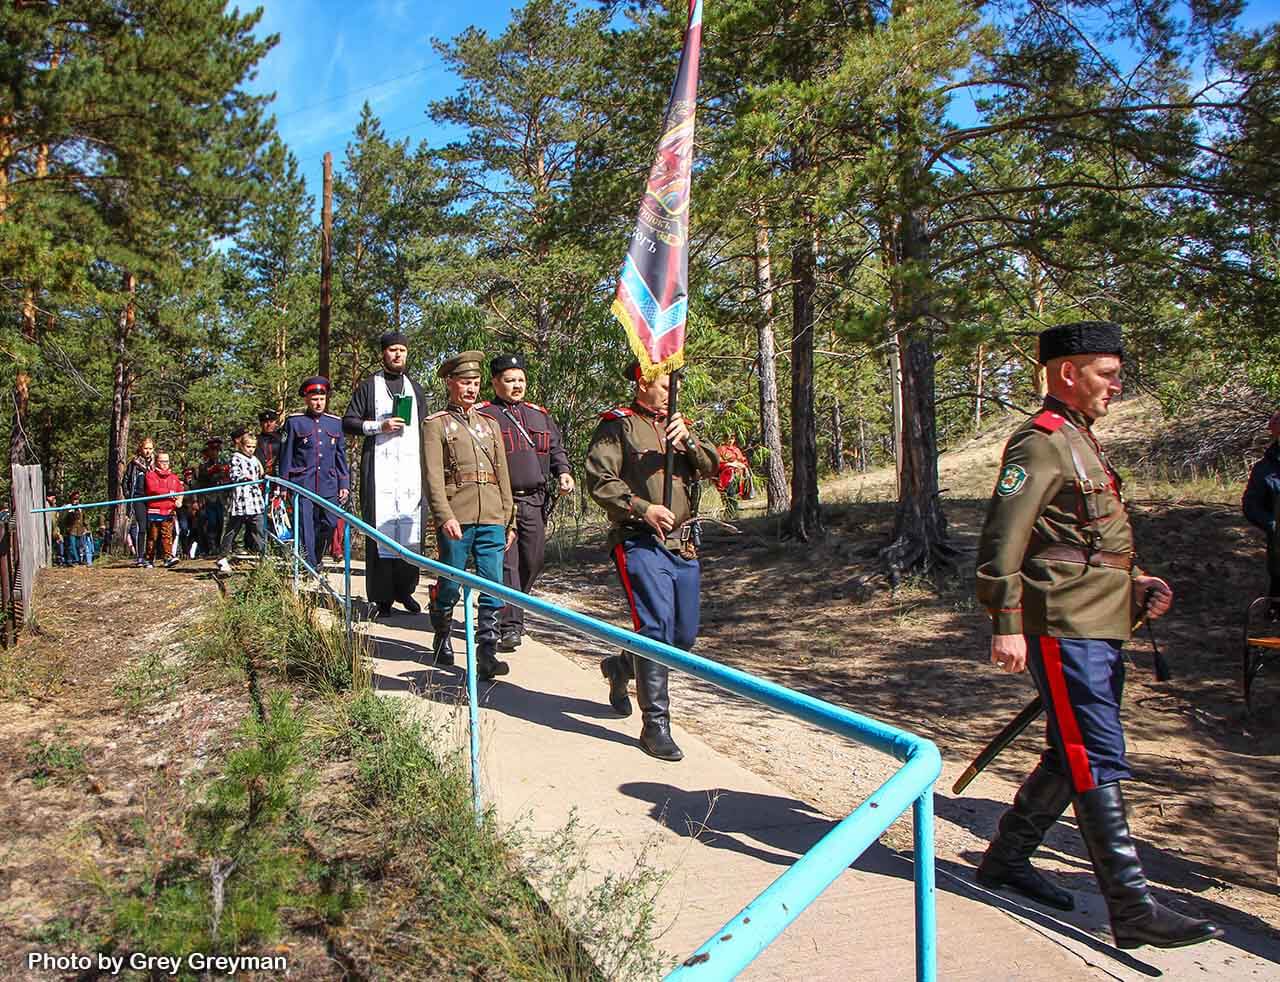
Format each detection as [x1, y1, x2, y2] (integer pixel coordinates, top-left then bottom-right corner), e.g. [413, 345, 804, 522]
[317, 563, 1280, 982]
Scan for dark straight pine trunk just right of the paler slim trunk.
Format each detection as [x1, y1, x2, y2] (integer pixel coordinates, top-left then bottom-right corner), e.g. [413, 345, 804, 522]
[787, 215, 824, 542]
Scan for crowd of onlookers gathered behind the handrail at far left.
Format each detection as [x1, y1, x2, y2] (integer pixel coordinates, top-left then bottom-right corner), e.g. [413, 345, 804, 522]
[47, 410, 280, 568]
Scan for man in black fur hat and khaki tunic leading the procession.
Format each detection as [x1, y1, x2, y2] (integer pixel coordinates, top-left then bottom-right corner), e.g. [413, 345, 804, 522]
[977, 321, 1222, 947]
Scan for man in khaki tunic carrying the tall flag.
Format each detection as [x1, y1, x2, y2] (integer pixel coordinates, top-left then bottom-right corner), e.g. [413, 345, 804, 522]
[586, 362, 719, 761]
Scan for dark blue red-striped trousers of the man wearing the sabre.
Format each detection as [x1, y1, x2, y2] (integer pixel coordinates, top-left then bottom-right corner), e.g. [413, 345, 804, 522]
[1027, 635, 1133, 793]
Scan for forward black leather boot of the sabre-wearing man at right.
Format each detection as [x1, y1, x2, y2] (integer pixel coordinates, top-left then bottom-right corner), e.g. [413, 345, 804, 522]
[1075, 782, 1222, 947]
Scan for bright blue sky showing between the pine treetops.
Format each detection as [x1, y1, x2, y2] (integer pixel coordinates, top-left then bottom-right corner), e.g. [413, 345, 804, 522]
[250, 0, 1280, 199]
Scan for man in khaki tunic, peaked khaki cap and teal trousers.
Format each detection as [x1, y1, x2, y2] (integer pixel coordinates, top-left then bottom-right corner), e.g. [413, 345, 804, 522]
[422, 351, 516, 681]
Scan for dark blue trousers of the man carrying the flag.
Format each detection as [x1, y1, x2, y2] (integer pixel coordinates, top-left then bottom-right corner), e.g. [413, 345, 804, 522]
[613, 535, 701, 652]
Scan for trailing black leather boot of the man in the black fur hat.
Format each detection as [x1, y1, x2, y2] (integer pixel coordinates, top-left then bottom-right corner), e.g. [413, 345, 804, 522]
[978, 764, 1075, 910]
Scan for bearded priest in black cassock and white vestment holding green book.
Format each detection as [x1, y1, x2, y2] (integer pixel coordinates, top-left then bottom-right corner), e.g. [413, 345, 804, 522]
[342, 330, 428, 617]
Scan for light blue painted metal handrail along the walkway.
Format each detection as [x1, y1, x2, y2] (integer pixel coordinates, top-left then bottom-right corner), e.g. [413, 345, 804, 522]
[33, 476, 942, 982]
